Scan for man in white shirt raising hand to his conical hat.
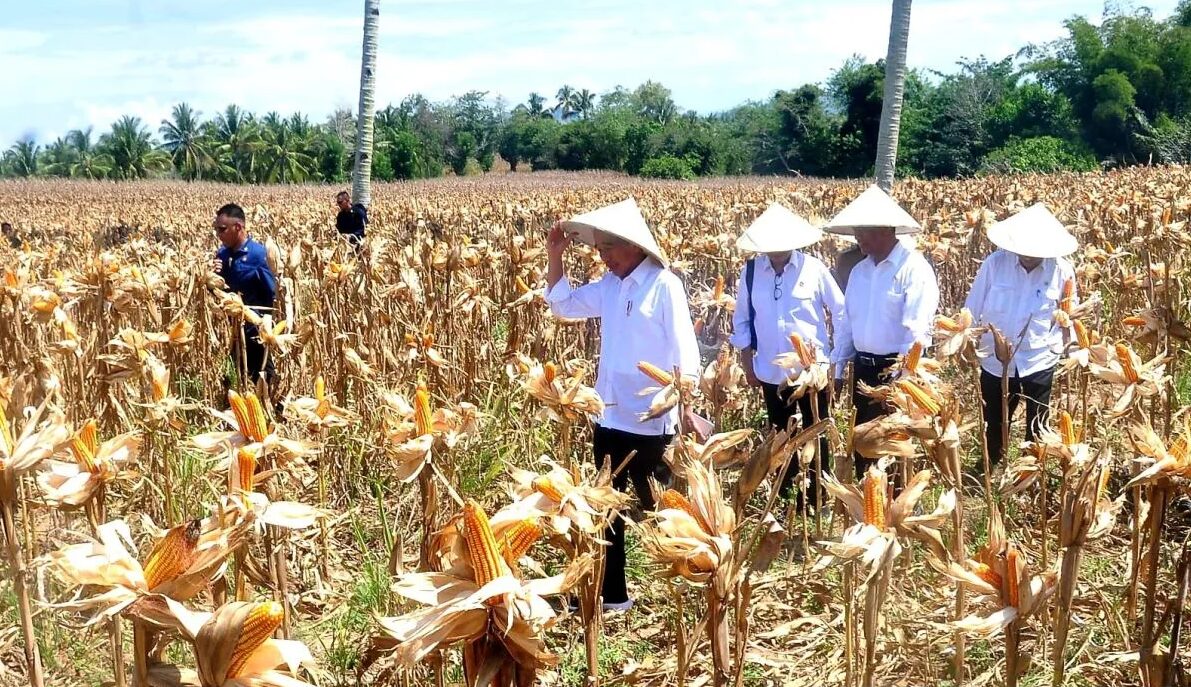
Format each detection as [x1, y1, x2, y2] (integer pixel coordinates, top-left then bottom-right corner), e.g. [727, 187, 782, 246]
[545, 198, 700, 611]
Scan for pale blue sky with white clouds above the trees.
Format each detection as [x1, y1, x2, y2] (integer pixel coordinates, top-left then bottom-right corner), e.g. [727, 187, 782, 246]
[0, 0, 1177, 146]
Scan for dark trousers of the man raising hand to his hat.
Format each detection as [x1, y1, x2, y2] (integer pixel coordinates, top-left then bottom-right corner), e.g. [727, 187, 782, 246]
[592, 425, 674, 604]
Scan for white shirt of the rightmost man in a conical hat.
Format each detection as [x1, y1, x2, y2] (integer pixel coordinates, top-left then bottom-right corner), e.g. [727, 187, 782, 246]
[964, 250, 1075, 377]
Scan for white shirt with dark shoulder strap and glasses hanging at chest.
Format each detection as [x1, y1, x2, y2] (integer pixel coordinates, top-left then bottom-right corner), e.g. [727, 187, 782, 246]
[730, 250, 844, 385]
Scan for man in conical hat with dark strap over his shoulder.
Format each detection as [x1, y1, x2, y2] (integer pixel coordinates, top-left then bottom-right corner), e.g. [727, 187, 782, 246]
[731, 204, 843, 510]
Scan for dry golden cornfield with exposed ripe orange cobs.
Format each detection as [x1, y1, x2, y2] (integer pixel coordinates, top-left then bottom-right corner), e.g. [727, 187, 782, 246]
[0, 168, 1191, 687]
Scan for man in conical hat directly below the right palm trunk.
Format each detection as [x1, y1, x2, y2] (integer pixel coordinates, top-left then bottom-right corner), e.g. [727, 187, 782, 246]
[824, 186, 939, 480]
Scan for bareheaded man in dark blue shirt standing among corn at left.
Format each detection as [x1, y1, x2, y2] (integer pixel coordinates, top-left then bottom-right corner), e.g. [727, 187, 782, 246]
[212, 202, 278, 387]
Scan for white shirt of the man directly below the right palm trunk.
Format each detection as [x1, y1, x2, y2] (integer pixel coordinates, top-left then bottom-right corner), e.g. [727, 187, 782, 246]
[831, 235, 939, 379]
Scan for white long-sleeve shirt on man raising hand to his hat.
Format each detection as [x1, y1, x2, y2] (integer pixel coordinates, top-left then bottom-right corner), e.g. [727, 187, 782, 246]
[545, 258, 700, 436]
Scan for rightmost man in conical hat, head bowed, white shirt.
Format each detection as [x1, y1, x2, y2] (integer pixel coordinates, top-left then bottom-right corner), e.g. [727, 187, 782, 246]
[965, 204, 1078, 464]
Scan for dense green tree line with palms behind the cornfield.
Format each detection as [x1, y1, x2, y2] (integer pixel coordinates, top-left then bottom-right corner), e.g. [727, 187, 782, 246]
[0, 0, 1191, 183]
